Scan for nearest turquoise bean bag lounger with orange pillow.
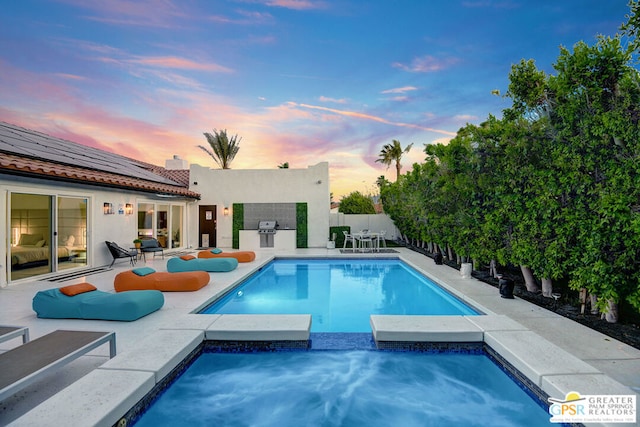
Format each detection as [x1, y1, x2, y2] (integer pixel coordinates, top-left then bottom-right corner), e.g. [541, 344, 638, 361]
[32, 283, 164, 322]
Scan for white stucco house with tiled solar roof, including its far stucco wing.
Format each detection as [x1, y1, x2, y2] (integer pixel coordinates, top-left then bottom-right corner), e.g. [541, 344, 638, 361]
[0, 122, 329, 287]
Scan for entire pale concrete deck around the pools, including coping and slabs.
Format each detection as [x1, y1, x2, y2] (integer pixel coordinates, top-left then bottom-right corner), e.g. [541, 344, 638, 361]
[0, 248, 640, 426]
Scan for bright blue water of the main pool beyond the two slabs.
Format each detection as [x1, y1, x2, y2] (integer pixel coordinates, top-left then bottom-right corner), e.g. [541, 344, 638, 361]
[200, 259, 480, 332]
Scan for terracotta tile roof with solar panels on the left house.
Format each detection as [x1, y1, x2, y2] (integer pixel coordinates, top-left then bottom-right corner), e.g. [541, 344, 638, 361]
[0, 122, 200, 199]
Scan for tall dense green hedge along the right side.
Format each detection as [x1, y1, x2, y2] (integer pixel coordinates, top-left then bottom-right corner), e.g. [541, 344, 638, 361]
[381, 18, 640, 318]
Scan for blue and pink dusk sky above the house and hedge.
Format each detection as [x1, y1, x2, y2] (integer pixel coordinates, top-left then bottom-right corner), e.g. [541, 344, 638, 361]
[0, 0, 629, 201]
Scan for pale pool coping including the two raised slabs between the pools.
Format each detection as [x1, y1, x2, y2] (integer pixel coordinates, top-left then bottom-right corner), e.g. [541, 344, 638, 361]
[9, 256, 636, 427]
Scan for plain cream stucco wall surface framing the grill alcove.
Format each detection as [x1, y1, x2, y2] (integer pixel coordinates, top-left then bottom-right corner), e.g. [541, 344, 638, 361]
[188, 162, 330, 248]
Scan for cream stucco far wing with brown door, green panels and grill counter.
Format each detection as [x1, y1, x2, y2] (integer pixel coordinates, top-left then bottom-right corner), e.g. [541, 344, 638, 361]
[190, 162, 330, 250]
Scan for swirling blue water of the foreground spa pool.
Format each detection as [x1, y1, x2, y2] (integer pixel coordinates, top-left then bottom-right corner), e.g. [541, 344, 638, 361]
[135, 350, 550, 427]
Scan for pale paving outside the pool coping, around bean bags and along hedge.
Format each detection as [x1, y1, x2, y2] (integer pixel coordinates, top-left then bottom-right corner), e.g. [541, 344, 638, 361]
[0, 248, 640, 426]
